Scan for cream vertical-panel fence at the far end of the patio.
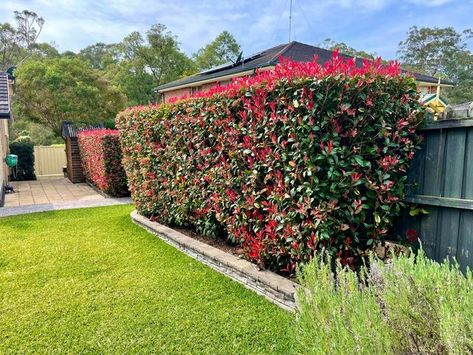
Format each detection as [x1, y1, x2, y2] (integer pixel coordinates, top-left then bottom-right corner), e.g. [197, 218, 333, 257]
[34, 146, 67, 176]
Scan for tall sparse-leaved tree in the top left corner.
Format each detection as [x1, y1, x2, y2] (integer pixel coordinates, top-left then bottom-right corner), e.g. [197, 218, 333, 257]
[0, 10, 44, 70]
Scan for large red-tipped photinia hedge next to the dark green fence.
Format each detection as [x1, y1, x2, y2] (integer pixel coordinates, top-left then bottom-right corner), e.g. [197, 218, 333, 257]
[116, 53, 422, 273]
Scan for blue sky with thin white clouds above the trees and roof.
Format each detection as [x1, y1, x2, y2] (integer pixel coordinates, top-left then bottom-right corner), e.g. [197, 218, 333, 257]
[0, 0, 473, 59]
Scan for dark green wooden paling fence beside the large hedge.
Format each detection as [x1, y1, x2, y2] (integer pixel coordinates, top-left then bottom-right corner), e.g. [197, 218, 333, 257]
[399, 119, 473, 269]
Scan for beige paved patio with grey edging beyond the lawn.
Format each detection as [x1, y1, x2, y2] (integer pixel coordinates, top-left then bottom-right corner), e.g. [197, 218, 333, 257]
[0, 177, 131, 217]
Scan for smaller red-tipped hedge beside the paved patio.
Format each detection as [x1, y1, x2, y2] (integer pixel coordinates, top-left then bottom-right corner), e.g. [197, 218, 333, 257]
[77, 129, 129, 196]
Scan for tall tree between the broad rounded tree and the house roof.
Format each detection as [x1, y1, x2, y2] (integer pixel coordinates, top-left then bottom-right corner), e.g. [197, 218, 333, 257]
[78, 24, 195, 105]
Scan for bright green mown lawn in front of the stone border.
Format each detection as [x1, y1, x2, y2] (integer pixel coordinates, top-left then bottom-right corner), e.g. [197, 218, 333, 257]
[0, 206, 292, 354]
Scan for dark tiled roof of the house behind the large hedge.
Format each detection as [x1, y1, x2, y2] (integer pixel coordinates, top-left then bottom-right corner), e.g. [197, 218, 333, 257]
[157, 41, 453, 91]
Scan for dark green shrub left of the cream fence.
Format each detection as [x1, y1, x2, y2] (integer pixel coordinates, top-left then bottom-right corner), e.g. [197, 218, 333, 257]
[10, 138, 36, 181]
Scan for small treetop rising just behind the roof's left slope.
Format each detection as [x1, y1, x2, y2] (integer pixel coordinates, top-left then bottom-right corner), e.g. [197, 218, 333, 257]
[193, 31, 241, 70]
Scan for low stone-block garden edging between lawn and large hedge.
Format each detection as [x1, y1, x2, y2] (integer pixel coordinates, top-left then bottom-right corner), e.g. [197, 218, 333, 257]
[131, 211, 297, 312]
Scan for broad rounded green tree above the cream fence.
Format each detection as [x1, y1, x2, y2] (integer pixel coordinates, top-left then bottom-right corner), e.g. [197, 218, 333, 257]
[14, 57, 126, 136]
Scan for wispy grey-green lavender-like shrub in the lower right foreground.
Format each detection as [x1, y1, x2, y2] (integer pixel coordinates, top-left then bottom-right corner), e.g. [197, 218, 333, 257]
[293, 250, 473, 354]
